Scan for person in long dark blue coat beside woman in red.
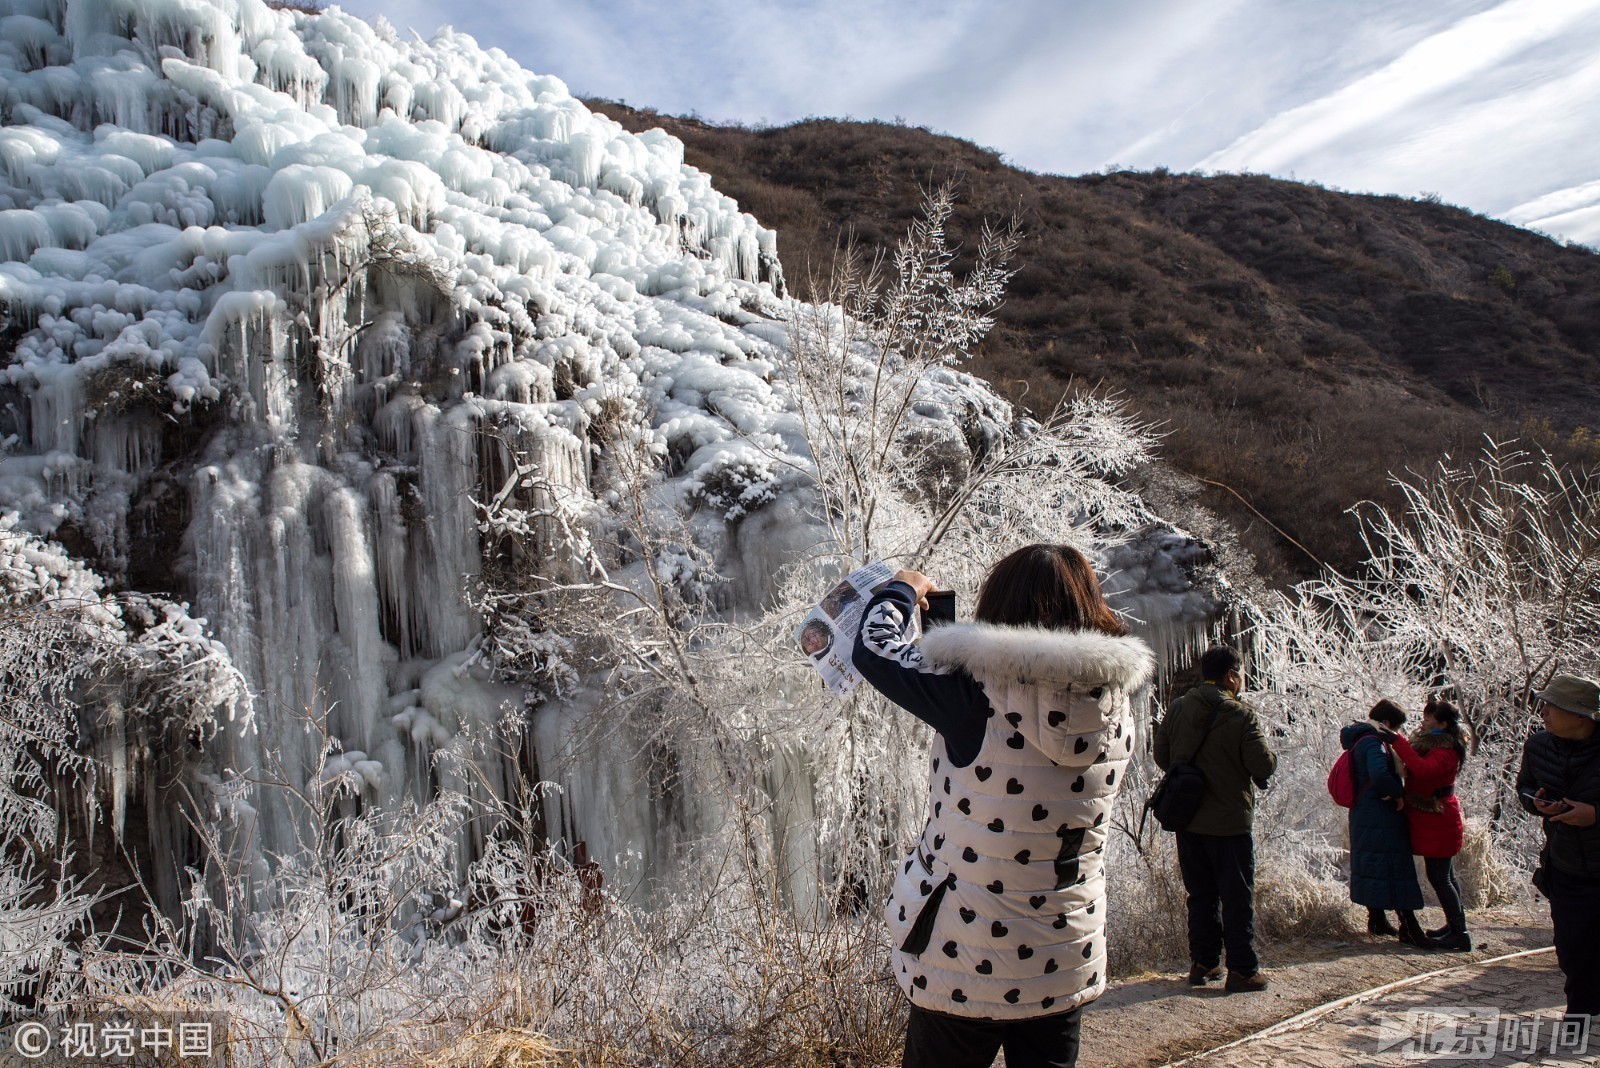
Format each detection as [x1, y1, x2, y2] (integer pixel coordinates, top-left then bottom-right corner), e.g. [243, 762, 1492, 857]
[1339, 700, 1434, 948]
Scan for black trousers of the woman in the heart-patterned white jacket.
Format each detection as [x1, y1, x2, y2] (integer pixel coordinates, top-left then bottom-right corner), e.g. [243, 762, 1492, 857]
[901, 1006, 1083, 1068]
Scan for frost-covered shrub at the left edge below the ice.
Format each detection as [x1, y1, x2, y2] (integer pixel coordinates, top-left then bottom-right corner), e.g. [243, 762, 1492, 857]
[0, 516, 248, 1015]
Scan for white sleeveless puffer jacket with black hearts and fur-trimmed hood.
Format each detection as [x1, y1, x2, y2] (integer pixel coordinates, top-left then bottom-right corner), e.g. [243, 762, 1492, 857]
[885, 624, 1154, 1020]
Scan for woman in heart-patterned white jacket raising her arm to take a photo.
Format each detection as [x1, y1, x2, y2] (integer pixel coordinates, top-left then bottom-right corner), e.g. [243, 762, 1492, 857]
[853, 545, 1154, 1068]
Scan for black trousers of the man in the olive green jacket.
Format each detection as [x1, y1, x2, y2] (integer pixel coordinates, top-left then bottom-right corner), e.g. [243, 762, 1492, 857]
[1178, 831, 1261, 975]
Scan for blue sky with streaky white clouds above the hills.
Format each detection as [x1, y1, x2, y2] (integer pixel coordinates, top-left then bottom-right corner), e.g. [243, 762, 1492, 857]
[341, 0, 1600, 243]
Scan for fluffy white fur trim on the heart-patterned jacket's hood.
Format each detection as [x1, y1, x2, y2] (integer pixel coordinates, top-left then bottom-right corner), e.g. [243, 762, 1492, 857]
[917, 624, 1155, 689]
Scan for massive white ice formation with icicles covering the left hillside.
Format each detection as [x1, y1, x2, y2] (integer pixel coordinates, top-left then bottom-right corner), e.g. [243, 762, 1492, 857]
[0, 0, 1203, 908]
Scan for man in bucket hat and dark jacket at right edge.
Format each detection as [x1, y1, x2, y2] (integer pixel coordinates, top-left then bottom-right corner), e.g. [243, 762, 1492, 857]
[1517, 675, 1600, 1018]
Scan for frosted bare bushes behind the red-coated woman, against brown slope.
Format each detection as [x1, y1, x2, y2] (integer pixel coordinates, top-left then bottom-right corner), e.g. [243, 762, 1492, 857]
[1251, 441, 1600, 857]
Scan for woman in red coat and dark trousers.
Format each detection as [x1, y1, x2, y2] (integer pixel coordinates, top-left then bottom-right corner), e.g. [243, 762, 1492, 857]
[1394, 697, 1472, 950]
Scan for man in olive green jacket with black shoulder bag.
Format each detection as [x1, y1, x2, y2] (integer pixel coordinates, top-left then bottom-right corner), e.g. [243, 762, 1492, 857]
[1155, 646, 1278, 991]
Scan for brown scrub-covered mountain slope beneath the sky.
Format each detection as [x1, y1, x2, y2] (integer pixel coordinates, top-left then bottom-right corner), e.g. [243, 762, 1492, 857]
[592, 101, 1600, 579]
